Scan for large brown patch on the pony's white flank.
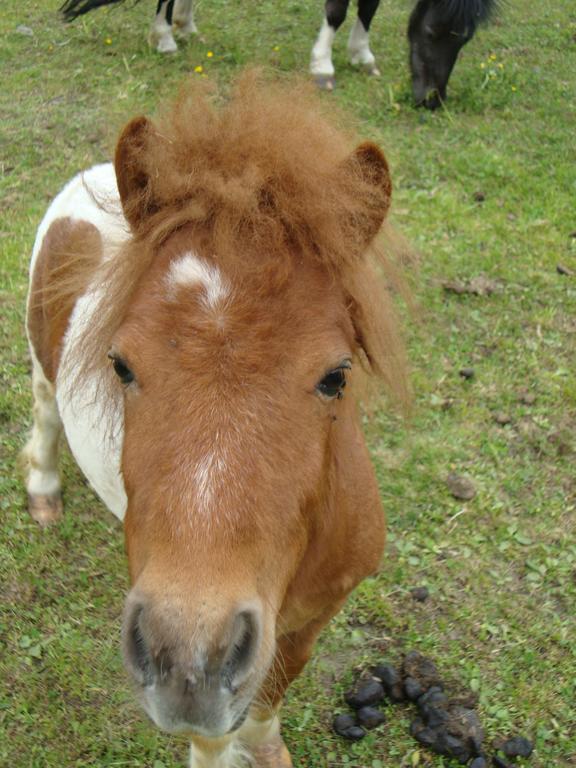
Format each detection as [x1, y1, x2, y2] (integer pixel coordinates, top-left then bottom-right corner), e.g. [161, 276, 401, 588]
[27, 218, 102, 382]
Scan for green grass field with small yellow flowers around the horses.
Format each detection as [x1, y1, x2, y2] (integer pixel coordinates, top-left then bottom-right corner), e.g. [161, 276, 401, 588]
[0, 0, 576, 768]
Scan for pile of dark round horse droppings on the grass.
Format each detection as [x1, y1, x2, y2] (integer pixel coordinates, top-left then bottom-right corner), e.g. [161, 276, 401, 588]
[333, 651, 533, 768]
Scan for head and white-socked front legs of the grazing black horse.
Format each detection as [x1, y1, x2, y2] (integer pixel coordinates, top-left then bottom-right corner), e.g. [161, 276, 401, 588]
[310, 0, 498, 109]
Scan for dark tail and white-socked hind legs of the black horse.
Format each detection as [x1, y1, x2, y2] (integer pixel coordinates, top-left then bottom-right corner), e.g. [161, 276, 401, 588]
[60, 0, 198, 53]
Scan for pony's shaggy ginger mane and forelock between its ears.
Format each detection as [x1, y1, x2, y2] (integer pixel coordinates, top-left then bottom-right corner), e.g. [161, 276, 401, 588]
[70, 72, 407, 408]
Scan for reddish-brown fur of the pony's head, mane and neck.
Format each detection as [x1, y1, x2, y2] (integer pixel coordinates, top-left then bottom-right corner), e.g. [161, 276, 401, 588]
[33, 75, 407, 752]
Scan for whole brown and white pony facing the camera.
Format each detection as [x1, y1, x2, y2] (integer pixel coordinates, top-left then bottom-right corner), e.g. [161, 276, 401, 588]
[24, 75, 405, 768]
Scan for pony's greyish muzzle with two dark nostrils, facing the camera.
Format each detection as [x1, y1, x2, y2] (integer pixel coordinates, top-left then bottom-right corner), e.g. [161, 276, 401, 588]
[122, 595, 262, 737]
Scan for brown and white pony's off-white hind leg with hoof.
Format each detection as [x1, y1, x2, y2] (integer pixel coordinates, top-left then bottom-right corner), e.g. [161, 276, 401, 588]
[22, 361, 62, 526]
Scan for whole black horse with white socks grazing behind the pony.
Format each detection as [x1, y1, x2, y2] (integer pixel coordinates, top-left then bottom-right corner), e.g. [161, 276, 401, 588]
[61, 0, 498, 109]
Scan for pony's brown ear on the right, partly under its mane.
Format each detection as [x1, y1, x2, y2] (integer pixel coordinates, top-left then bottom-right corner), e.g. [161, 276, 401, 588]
[344, 141, 392, 253]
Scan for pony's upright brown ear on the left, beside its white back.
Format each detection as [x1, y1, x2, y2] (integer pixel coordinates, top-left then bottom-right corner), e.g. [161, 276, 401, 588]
[114, 117, 158, 230]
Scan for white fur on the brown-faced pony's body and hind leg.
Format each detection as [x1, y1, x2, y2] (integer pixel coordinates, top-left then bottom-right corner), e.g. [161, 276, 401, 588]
[26, 163, 129, 518]
